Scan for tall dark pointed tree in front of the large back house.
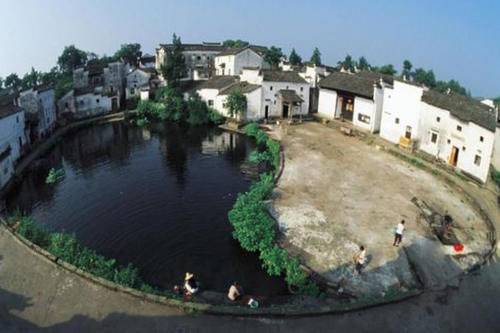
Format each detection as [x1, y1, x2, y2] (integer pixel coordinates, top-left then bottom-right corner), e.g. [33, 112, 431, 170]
[161, 33, 186, 88]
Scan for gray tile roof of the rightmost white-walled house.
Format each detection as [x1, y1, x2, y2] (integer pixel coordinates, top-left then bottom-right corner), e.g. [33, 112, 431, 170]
[422, 90, 497, 132]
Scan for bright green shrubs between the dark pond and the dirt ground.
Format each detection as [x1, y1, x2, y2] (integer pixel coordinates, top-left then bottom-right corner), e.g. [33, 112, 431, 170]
[228, 124, 319, 295]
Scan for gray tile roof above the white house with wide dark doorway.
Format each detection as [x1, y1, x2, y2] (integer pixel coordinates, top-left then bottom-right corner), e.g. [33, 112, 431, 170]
[318, 72, 376, 99]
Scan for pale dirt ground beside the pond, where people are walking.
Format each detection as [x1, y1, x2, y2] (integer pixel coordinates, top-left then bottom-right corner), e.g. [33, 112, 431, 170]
[271, 122, 489, 295]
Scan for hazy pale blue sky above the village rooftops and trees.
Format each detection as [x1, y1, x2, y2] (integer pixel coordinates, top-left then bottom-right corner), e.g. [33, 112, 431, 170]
[0, 0, 500, 96]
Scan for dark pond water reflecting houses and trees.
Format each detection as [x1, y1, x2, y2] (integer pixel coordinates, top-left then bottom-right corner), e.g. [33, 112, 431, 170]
[7, 123, 286, 295]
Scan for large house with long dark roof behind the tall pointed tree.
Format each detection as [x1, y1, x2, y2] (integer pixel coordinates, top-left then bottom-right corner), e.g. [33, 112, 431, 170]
[156, 42, 225, 81]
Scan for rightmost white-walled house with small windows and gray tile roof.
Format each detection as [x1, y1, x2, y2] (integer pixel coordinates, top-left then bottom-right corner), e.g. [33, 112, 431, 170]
[419, 90, 496, 182]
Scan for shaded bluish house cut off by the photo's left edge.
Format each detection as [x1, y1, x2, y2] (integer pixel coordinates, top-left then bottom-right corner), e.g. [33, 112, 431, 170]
[0, 89, 28, 189]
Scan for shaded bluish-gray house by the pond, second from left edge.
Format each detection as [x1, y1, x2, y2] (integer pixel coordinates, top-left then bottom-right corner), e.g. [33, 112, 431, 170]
[18, 86, 57, 143]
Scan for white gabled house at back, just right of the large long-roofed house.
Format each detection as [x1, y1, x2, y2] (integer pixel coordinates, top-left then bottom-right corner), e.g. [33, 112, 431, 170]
[214, 45, 271, 75]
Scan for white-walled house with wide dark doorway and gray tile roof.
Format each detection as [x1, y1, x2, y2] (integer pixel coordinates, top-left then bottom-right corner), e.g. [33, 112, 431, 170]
[318, 72, 386, 133]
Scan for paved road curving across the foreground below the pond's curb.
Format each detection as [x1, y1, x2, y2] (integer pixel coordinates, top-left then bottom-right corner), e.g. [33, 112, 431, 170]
[0, 223, 500, 333]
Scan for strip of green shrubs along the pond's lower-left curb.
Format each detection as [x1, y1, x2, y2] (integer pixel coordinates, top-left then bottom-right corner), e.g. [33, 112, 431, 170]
[3, 212, 155, 295]
